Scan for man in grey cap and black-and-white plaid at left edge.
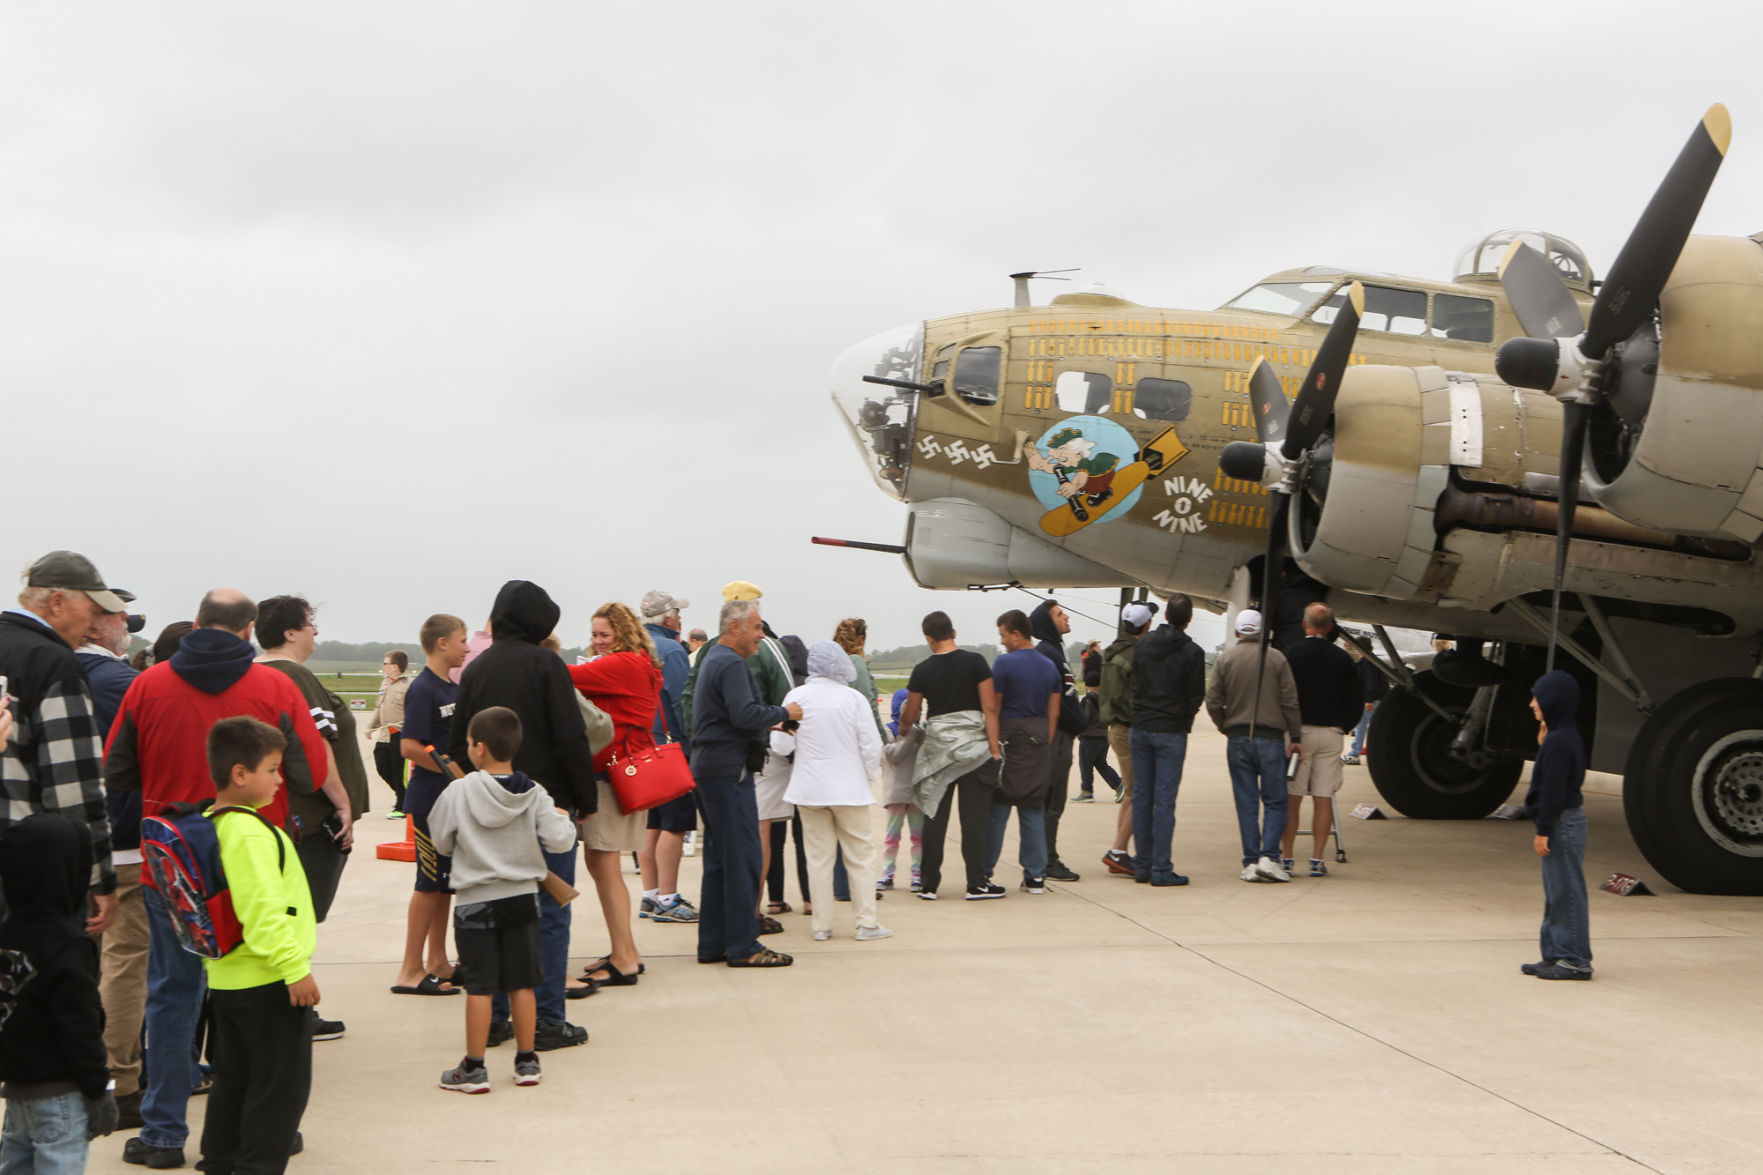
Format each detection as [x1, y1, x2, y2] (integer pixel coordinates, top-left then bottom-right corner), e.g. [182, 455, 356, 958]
[0, 550, 134, 933]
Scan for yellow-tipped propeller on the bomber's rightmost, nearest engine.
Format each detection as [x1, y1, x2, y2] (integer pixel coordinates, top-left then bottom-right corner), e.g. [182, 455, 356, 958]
[1493, 102, 1733, 669]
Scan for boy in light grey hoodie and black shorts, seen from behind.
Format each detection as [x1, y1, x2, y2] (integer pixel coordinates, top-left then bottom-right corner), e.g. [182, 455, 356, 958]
[428, 706, 575, 1094]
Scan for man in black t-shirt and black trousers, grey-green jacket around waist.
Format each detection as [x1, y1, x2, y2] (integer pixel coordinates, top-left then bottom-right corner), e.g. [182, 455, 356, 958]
[899, 612, 1003, 902]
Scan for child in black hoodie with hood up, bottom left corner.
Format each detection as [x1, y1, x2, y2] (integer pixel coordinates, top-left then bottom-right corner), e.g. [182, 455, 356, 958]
[0, 815, 116, 1171]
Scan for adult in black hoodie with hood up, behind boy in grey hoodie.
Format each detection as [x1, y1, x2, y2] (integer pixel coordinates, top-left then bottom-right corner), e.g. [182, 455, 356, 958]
[448, 579, 599, 1052]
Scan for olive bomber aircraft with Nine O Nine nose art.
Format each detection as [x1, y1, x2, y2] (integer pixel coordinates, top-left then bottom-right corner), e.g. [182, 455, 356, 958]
[832, 106, 1763, 894]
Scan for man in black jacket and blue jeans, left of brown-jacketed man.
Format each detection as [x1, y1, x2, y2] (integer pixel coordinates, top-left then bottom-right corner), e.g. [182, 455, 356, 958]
[1132, 595, 1206, 886]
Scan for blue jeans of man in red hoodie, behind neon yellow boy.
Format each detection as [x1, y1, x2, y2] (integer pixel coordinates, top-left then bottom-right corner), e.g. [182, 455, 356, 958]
[141, 889, 208, 1150]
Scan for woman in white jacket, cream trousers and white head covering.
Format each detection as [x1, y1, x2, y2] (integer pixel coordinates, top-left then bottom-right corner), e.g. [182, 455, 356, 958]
[786, 640, 894, 940]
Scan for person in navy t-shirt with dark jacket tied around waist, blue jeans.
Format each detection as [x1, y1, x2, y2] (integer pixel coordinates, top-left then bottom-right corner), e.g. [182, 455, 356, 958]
[987, 609, 1065, 894]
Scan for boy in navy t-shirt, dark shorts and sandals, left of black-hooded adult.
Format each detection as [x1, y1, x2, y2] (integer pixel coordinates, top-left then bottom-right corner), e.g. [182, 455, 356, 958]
[391, 612, 469, 995]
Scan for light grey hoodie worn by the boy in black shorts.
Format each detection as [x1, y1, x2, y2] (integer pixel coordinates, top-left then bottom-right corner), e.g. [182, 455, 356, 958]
[428, 771, 575, 905]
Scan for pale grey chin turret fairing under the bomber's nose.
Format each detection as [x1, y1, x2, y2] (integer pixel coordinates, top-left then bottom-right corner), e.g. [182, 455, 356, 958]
[906, 498, 1137, 591]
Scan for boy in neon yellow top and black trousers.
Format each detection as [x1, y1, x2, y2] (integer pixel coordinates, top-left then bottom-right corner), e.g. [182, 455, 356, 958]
[203, 716, 319, 1171]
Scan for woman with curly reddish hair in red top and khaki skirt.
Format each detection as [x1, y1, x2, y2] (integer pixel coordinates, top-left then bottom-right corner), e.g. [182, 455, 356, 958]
[569, 603, 661, 993]
